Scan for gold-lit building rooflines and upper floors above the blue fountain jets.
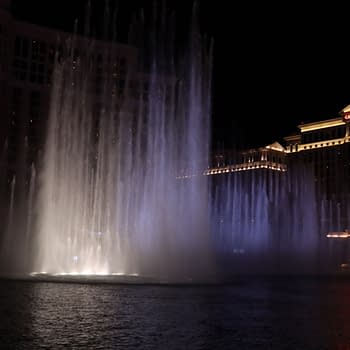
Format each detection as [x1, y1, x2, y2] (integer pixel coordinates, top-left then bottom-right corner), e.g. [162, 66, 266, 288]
[209, 105, 350, 199]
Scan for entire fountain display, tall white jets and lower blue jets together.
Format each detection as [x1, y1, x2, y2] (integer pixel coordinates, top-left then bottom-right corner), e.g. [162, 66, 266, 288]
[1, 2, 348, 282]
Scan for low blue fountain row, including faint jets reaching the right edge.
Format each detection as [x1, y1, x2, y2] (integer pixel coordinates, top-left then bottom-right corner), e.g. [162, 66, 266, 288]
[211, 154, 350, 275]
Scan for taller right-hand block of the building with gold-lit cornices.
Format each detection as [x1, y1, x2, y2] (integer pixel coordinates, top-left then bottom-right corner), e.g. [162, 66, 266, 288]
[284, 106, 350, 199]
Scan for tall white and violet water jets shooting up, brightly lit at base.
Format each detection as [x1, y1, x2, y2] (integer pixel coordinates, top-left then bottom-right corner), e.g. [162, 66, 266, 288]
[33, 2, 212, 280]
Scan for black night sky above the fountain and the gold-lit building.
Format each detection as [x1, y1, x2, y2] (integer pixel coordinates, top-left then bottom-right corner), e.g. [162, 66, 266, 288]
[13, 0, 350, 147]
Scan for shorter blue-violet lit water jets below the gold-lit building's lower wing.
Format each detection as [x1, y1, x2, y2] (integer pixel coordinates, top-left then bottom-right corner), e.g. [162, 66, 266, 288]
[213, 163, 321, 273]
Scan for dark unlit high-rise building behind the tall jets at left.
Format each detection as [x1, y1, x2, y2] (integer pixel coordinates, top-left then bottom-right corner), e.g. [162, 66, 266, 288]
[0, 0, 139, 178]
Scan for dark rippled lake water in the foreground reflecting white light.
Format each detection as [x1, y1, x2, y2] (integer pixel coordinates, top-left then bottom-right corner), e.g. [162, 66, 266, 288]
[0, 276, 350, 350]
